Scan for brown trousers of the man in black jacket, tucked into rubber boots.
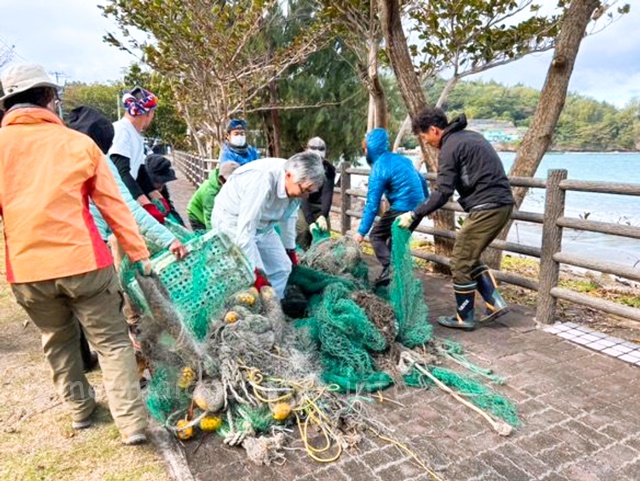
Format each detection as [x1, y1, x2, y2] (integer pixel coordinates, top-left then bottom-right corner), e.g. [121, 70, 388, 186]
[451, 205, 513, 284]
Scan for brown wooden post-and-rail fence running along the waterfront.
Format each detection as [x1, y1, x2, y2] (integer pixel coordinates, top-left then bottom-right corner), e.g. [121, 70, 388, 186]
[174, 152, 640, 323]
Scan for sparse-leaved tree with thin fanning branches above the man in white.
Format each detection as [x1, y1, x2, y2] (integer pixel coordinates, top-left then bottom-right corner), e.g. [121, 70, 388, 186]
[102, 0, 324, 147]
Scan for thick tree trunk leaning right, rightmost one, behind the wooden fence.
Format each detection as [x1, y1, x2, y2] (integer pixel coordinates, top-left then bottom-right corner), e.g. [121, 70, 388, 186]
[484, 0, 600, 269]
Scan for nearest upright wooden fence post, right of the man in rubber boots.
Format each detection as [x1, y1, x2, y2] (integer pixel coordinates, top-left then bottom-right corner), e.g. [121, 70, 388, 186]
[536, 169, 567, 324]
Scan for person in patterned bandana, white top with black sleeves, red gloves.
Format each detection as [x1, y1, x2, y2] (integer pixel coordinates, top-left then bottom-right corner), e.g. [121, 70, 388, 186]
[109, 87, 165, 224]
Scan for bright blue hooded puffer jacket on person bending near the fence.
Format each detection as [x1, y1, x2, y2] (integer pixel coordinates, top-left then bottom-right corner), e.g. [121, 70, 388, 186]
[358, 129, 429, 236]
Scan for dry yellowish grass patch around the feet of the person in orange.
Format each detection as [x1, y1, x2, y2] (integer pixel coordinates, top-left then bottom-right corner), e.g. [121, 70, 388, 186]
[0, 224, 169, 481]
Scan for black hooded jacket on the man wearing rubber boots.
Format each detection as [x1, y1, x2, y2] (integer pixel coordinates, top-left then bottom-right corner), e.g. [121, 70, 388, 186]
[415, 114, 514, 218]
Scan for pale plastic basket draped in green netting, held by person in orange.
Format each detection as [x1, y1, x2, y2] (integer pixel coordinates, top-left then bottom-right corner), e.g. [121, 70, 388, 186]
[125, 232, 254, 339]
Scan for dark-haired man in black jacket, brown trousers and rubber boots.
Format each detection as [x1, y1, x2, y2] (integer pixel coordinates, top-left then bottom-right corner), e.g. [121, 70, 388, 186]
[399, 107, 514, 330]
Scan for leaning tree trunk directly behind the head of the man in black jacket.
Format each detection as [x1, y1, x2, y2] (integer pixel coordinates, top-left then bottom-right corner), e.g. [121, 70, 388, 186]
[378, 0, 455, 273]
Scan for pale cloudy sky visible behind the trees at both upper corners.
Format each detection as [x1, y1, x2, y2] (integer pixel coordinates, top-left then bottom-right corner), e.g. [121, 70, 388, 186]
[0, 0, 640, 107]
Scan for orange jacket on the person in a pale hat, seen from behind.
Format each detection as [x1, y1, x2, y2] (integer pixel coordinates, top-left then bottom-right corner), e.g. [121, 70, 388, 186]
[0, 107, 149, 284]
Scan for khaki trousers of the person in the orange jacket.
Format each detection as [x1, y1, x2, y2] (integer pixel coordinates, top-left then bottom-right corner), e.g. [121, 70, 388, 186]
[11, 267, 147, 436]
